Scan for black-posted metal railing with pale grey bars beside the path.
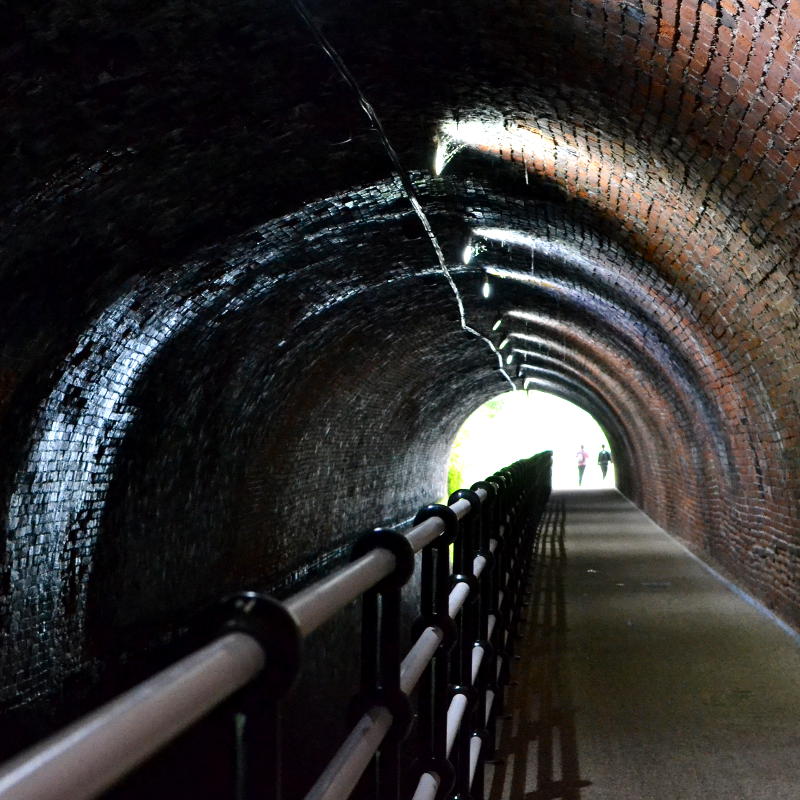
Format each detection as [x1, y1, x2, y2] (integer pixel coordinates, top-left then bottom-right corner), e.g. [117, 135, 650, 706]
[0, 452, 551, 800]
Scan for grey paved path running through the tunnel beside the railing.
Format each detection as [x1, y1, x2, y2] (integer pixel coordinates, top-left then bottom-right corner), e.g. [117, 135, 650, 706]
[486, 490, 800, 800]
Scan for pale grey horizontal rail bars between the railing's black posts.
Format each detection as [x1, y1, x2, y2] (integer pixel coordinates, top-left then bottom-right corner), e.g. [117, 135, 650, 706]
[0, 454, 552, 800]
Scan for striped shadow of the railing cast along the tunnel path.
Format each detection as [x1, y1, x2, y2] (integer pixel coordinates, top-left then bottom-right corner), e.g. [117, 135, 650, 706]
[486, 500, 591, 800]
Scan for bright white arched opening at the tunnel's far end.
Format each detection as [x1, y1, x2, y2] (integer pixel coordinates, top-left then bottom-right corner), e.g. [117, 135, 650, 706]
[447, 391, 616, 492]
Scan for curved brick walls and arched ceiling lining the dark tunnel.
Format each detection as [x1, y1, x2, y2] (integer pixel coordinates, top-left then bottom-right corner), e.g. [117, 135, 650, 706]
[0, 0, 800, 780]
